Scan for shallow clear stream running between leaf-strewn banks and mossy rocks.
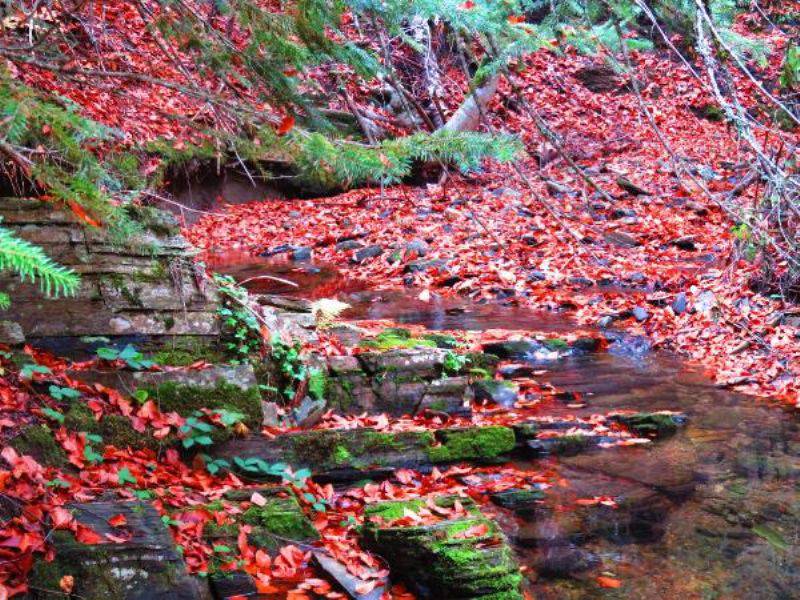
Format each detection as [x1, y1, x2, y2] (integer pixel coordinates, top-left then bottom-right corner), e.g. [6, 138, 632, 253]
[213, 258, 800, 599]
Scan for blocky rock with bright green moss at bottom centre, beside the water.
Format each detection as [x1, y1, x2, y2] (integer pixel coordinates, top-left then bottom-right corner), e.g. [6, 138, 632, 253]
[362, 496, 523, 600]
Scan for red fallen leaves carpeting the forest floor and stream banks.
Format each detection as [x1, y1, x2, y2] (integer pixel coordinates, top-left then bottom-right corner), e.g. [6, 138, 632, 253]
[0, 5, 800, 600]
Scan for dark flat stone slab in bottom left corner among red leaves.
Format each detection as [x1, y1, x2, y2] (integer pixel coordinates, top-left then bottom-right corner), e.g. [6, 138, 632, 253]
[31, 501, 211, 600]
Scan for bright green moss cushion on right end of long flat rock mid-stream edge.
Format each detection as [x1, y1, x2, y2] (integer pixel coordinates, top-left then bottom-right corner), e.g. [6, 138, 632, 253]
[427, 426, 516, 463]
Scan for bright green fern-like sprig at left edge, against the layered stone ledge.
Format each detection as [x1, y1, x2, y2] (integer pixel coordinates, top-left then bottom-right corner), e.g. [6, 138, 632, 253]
[0, 227, 80, 300]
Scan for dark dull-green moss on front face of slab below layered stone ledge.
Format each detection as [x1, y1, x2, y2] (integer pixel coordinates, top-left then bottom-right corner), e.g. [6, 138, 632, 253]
[144, 380, 262, 430]
